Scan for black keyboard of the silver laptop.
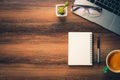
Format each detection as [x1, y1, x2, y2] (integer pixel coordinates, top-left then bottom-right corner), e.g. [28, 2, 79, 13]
[88, 0, 120, 16]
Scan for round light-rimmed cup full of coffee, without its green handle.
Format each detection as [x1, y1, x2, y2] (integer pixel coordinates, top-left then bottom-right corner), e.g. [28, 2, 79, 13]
[106, 50, 120, 73]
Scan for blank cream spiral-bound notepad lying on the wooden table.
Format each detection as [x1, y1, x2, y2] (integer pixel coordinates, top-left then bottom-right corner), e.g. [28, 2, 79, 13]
[68, 32, 92, 65]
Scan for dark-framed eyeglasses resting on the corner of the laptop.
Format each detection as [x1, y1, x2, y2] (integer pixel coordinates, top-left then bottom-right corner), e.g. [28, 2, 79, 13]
[72, 5, 102, 17]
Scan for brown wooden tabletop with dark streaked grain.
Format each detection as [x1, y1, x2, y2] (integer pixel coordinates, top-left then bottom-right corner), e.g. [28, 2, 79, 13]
[0, 0, 120, 80]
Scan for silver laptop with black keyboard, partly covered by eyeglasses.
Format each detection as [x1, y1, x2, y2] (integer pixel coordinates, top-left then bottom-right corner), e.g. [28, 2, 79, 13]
[73, 0, 120, 35]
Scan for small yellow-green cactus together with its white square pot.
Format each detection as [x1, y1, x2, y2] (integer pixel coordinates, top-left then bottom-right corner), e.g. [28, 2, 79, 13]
[56, 0, 69, 17]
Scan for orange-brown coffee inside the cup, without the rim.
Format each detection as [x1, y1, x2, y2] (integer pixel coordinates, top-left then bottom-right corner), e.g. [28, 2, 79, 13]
[108, 52, 120, 70]
